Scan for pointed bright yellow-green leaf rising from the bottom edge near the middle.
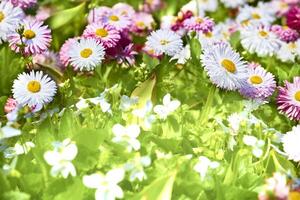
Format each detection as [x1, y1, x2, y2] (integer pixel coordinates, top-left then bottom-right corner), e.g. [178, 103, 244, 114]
[132, 171, 176, 200]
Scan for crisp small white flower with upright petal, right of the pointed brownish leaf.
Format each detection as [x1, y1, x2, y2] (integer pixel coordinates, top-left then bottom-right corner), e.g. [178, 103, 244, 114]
[153, 93, 180, 120]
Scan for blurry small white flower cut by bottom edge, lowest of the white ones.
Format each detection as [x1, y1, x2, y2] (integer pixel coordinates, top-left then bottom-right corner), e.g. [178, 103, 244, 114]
[83, 168, 125, 200]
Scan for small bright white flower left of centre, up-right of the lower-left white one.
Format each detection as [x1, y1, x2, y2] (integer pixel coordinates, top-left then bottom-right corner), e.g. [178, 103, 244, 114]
[112, 124, 141, 152]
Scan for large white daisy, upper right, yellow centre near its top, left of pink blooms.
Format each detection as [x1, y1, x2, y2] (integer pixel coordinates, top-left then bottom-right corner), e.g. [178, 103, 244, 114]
[241, 26, 281, 57]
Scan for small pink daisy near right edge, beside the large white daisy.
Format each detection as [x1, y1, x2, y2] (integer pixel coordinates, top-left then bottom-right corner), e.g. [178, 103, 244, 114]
[271, 25, 299, 42]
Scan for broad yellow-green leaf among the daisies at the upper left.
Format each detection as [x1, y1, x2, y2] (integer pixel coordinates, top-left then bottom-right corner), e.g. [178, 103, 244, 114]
[47, 2, 85, 29]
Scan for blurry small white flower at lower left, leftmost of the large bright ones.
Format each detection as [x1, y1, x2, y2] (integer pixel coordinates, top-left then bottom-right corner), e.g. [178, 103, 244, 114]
[44, 138, 78, 178]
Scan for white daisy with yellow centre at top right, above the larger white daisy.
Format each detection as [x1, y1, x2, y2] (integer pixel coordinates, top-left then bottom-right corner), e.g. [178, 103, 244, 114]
[236, 4, 276, 26]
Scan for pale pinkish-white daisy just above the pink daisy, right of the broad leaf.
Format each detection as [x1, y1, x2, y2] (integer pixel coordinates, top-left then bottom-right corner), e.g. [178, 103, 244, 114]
[100, 10, 131, 31]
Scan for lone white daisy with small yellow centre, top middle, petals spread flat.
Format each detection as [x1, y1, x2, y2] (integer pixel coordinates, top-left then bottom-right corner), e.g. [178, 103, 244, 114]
[146, 29, 183, 56]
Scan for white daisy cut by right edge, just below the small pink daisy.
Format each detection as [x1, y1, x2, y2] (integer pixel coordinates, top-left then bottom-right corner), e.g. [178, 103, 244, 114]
[276, 39, 300, 62]
